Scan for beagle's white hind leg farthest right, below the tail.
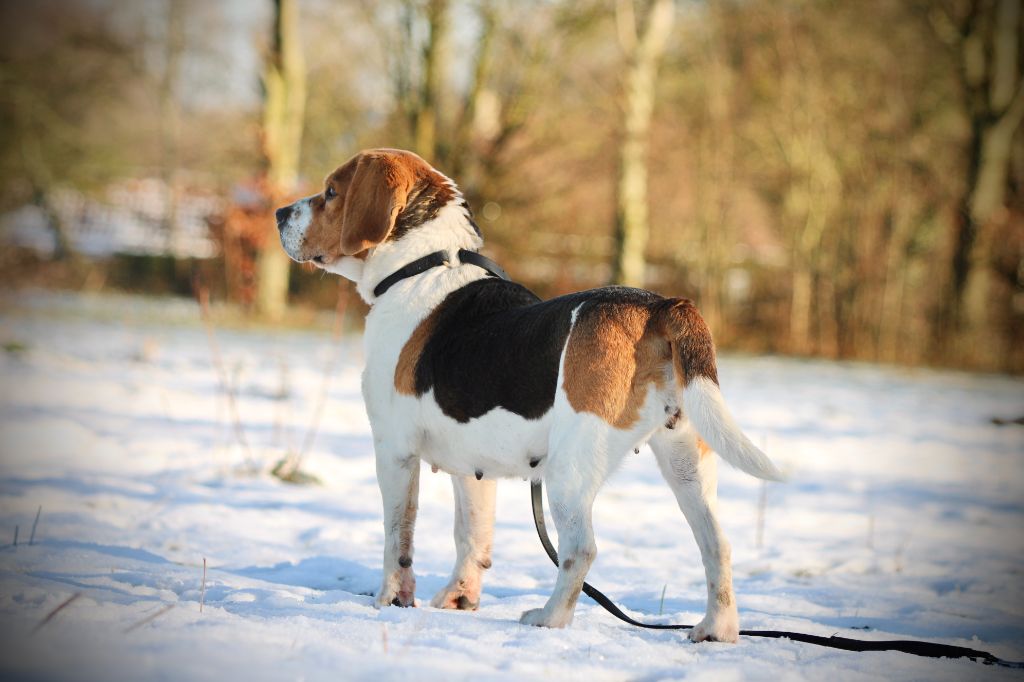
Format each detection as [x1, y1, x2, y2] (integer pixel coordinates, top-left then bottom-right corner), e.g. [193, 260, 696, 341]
[650, 423, 739, 642]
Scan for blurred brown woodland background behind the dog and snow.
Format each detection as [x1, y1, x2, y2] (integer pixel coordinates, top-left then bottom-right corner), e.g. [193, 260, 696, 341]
[0, 0, 1024, 372]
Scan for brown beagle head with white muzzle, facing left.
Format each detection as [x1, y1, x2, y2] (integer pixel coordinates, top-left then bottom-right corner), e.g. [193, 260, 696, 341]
[275, 150, 456, 269]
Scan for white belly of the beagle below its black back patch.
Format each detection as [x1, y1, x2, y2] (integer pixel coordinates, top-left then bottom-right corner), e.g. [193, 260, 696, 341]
[418, 394, 551, 478]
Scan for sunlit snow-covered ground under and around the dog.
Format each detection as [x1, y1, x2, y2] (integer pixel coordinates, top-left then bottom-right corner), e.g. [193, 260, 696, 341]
[0, 294, 1024, 681]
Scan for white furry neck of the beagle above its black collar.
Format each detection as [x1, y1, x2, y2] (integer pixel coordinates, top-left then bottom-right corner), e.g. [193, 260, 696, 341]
[326, 185, 486, 305]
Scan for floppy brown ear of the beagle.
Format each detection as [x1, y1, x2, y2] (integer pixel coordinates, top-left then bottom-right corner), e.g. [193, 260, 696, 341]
[341, 153, 416, 256]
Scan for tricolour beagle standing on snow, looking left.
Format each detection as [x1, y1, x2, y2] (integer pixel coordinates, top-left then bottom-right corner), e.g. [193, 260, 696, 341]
[276, 148, 781, 642]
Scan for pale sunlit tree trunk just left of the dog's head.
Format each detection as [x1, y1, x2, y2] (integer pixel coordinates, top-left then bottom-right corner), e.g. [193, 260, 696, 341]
[256, 0, 306, 319]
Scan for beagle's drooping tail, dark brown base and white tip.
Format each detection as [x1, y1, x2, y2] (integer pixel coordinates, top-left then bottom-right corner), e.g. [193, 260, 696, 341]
[654, 298, 784, 480]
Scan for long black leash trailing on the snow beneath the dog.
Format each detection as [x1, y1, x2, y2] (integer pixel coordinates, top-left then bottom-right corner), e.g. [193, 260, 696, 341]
[530, 480, 1024, 669]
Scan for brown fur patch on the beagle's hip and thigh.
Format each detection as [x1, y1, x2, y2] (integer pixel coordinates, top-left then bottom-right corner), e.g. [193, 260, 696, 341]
[563, 303, 672, 429]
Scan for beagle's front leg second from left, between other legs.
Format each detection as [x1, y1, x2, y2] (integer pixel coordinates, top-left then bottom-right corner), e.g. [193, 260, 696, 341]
[430, 476, 498, 610]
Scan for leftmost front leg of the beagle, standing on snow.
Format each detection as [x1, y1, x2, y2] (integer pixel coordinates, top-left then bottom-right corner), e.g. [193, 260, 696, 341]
[377, 452, 420, 607]
